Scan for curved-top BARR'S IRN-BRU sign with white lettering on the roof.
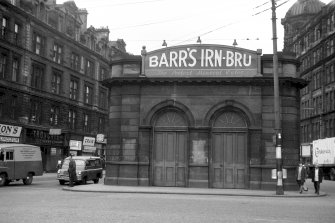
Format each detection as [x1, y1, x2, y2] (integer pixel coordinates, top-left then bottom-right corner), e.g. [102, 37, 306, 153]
[145, 45, 260, 77]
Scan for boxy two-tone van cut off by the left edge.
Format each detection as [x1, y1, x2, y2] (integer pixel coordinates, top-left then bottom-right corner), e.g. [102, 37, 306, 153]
[0, 143, 43, 186]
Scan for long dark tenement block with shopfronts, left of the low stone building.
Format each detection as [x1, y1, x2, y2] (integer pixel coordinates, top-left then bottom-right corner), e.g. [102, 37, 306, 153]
[0, 0, 125, 171]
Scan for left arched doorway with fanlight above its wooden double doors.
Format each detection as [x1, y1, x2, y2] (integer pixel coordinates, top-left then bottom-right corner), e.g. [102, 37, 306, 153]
[153, 110, 187, 187]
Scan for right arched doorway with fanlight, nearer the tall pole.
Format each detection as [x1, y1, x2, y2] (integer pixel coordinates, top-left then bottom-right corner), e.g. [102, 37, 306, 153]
[212, 111, 248, 188]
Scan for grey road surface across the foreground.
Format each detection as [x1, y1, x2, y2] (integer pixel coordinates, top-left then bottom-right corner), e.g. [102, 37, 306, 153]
[0, 174, 335, 223]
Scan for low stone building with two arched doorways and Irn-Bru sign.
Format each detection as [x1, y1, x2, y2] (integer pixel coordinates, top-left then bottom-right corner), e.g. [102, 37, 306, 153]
[104, 44, 306, 190]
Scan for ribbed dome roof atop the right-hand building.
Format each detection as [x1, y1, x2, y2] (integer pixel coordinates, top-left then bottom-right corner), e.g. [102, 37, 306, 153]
[285, 0, 325, 18]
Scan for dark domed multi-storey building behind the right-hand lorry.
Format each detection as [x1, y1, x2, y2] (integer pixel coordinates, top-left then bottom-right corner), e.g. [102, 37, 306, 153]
[282, 0, 335, 160]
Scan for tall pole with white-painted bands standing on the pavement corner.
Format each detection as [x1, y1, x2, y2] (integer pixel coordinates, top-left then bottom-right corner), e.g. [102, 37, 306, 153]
[271, 0, 284, 195]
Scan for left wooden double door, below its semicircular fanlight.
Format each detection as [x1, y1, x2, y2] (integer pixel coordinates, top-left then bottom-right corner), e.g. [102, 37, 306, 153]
[153, 131, 187, 187]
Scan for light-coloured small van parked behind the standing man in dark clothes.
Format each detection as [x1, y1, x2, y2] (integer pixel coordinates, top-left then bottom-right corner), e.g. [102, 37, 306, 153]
[57, 156, 103, 185]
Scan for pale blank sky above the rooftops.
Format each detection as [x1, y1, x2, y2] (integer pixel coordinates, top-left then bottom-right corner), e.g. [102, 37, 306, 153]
[57, 0, 332, 55]
